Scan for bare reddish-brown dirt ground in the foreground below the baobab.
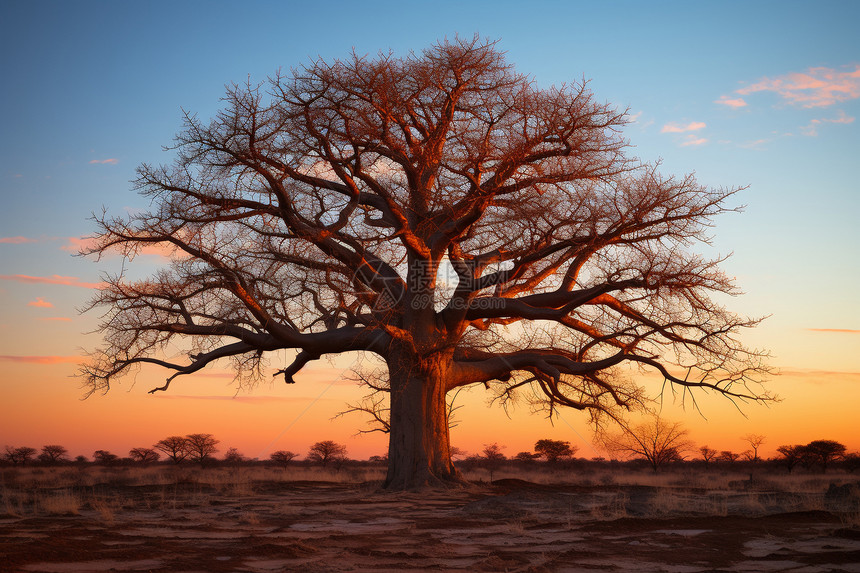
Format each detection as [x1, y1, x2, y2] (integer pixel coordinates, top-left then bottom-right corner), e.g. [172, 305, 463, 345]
[0, 480, 860, 573]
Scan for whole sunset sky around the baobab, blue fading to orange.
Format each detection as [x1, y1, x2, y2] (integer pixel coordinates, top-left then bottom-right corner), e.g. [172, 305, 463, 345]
[0, 0, 860, 458]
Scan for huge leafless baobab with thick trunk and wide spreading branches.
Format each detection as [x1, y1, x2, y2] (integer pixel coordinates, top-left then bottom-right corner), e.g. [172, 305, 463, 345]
[84, 39, 767, 488]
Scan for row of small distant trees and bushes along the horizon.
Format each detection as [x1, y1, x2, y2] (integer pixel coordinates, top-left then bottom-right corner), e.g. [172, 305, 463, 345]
[0, 434, 860, 474]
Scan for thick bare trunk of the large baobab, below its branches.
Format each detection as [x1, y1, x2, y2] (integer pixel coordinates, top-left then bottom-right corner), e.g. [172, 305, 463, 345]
[385, 346, 463, 490]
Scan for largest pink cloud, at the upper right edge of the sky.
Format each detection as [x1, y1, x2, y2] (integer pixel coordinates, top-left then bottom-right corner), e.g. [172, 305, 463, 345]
[737, 64, 860, 107]
